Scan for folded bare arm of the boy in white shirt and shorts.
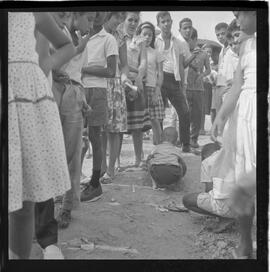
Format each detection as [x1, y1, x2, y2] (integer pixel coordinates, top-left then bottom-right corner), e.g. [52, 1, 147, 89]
[82, 55, 116, 78]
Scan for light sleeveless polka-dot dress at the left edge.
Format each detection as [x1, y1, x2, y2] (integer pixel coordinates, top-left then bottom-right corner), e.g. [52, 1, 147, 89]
[8, 12, 70, 212]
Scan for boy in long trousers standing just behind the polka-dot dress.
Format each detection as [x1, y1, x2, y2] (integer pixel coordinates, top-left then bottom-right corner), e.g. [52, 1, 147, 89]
[53, 12, 95, 228]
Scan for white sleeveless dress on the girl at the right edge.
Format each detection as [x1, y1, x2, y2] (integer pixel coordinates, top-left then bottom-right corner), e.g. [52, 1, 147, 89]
[211, 37, 257, 193]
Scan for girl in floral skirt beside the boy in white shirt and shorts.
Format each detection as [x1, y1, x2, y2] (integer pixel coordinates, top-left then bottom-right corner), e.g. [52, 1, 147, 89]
[100, 12, 132, 183]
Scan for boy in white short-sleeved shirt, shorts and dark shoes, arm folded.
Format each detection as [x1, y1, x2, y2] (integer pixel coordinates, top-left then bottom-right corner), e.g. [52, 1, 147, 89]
[81, 12, 118, 201]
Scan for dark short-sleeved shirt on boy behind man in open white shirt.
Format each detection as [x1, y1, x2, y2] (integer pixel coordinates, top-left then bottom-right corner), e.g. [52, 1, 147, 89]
[187, 48, 208, 91]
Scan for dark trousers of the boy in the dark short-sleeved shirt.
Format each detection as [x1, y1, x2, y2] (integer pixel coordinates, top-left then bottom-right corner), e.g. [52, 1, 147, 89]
[187, 90, 204, 141]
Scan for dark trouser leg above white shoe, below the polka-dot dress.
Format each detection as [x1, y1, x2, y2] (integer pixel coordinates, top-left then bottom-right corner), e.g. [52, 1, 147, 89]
[35, 198, 58, 249]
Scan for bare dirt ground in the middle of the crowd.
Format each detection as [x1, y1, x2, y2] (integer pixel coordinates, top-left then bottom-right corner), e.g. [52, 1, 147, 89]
[31, 113, 255, 259]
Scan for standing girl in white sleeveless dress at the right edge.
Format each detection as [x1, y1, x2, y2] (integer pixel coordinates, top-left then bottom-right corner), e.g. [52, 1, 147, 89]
[211, 11, 257, 258]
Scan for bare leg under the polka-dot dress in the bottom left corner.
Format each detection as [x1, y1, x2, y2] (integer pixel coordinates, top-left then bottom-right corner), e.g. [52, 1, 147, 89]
[9, 201, 35, 259]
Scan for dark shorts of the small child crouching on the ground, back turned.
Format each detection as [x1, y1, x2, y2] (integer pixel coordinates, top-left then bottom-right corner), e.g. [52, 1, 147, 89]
[150, 164, 186, 186]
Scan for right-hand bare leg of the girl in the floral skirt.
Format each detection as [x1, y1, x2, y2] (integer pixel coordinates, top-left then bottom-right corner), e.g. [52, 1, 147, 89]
[107, 133, 120, 178]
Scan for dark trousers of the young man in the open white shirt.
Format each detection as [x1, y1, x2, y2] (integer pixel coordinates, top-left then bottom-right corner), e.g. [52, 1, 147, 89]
[161, 72, 190, 145]
